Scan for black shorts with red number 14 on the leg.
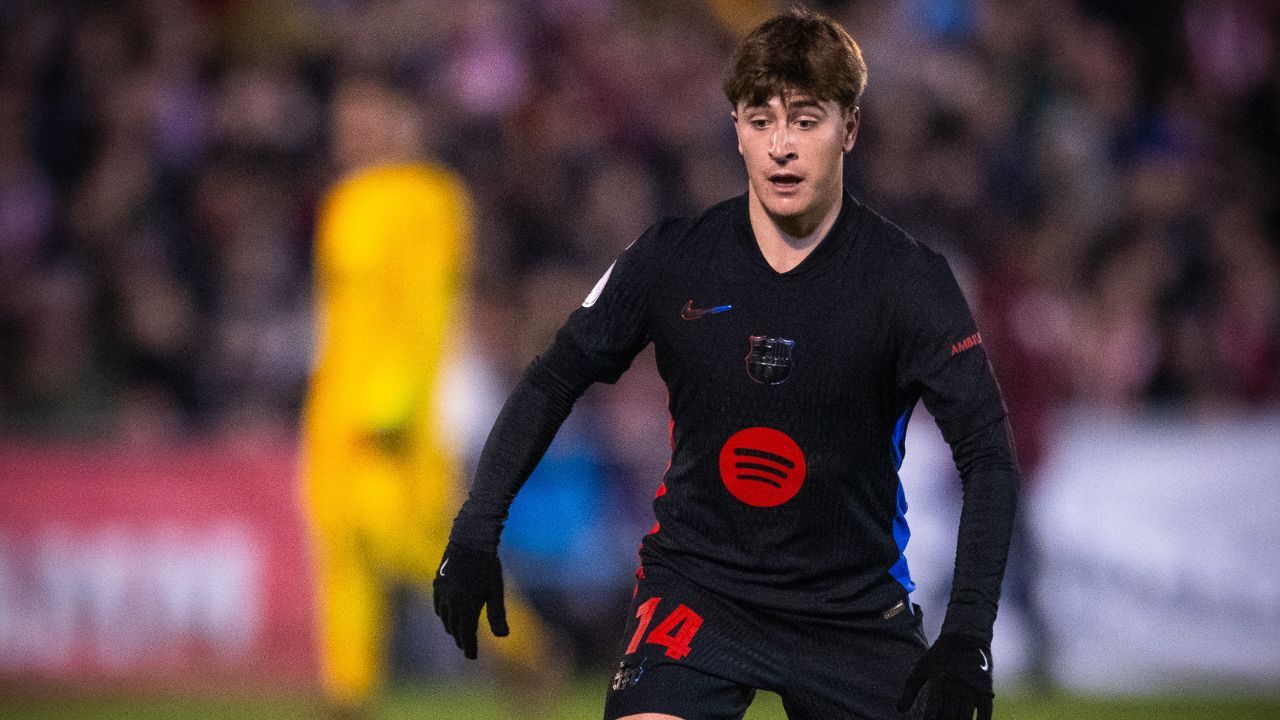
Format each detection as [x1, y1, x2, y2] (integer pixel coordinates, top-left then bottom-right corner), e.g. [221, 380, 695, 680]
[604, 565, 927, 720]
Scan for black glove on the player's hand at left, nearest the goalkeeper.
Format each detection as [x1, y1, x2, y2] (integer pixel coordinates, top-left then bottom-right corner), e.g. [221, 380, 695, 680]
[431, 542, 511, 660]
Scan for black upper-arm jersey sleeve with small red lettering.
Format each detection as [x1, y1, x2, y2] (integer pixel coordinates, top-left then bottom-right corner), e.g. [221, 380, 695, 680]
[896, 249, 1005, 445]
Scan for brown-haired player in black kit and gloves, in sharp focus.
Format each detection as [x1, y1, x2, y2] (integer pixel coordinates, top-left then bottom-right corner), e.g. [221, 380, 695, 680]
[435, 10, 1018, 720]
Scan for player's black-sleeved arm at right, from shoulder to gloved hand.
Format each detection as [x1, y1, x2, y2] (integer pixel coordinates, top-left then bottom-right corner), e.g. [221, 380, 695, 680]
[899, 252, 1019, 720]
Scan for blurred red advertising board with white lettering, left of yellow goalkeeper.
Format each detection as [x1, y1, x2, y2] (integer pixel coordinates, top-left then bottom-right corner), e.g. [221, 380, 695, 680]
[0, 442, 315, 687]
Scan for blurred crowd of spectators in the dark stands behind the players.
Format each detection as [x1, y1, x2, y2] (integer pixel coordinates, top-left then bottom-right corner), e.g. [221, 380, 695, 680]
[0, 0, 1280, 443]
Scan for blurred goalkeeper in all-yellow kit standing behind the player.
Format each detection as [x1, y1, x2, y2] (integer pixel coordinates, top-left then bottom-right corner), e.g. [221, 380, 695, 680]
[303, 79, 560, 717]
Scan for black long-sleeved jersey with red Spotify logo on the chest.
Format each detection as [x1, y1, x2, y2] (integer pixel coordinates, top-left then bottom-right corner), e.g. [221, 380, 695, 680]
[452, 195, 1018, 639]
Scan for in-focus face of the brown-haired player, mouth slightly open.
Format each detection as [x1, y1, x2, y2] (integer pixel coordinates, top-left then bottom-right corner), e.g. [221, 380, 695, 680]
[733, 95, 858, 227]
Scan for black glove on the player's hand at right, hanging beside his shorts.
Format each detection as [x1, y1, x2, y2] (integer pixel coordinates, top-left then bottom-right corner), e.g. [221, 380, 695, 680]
[897, 633, 995, 720]
